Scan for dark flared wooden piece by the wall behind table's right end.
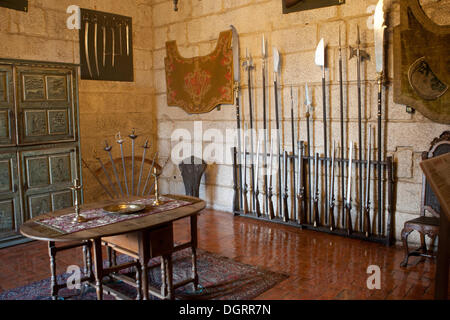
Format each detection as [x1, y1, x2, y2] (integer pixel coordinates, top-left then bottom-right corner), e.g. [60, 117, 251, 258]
[178, 156, 206, 197]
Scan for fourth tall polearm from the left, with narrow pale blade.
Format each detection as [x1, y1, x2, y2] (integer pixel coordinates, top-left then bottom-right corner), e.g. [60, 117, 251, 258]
[273, 47, 287, 221]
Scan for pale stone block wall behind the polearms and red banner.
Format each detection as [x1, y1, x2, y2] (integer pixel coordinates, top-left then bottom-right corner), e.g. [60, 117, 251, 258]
[152, 0, 450, 244]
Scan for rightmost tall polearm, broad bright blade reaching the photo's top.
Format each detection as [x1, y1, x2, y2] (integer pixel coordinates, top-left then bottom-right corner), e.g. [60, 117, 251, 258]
[374, 0, 386, 234]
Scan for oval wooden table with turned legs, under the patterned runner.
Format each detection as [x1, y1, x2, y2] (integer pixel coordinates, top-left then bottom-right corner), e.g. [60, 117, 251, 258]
[20, 195, 205, 300]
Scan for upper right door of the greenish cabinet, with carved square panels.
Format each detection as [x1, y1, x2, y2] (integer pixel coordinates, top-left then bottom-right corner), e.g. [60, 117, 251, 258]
[16, 67, 76, 144]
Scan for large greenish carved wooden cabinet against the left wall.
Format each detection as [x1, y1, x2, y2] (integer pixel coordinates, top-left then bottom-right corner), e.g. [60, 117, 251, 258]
[0, 59, 81, 248]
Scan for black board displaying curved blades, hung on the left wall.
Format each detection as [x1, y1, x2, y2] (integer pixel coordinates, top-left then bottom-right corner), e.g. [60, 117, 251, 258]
[80, 9, 134, 82]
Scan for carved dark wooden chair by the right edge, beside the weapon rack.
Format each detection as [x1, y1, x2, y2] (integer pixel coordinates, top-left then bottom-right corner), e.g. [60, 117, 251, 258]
[400, 131, 450, 267]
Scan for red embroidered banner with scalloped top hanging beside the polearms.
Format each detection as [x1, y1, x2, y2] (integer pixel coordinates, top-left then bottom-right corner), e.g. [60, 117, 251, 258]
[164, 30, 233, 113]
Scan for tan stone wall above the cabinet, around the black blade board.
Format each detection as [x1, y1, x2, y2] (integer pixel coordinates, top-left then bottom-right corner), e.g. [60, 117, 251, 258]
[0, 0, 156, 201]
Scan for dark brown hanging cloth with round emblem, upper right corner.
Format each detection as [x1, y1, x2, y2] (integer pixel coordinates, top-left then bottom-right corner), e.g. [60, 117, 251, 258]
[394, 0, 450, 124]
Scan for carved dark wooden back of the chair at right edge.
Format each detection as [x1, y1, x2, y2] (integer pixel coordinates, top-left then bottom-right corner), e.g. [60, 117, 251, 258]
[420, 131, 450, 218]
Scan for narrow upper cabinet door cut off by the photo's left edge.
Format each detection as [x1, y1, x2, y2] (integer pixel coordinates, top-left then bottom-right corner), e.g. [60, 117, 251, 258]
[0, 64, 15, 146]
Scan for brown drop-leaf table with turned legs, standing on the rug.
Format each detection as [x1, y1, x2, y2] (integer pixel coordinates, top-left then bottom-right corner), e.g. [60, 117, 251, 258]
[20, 195, 205, 300]
